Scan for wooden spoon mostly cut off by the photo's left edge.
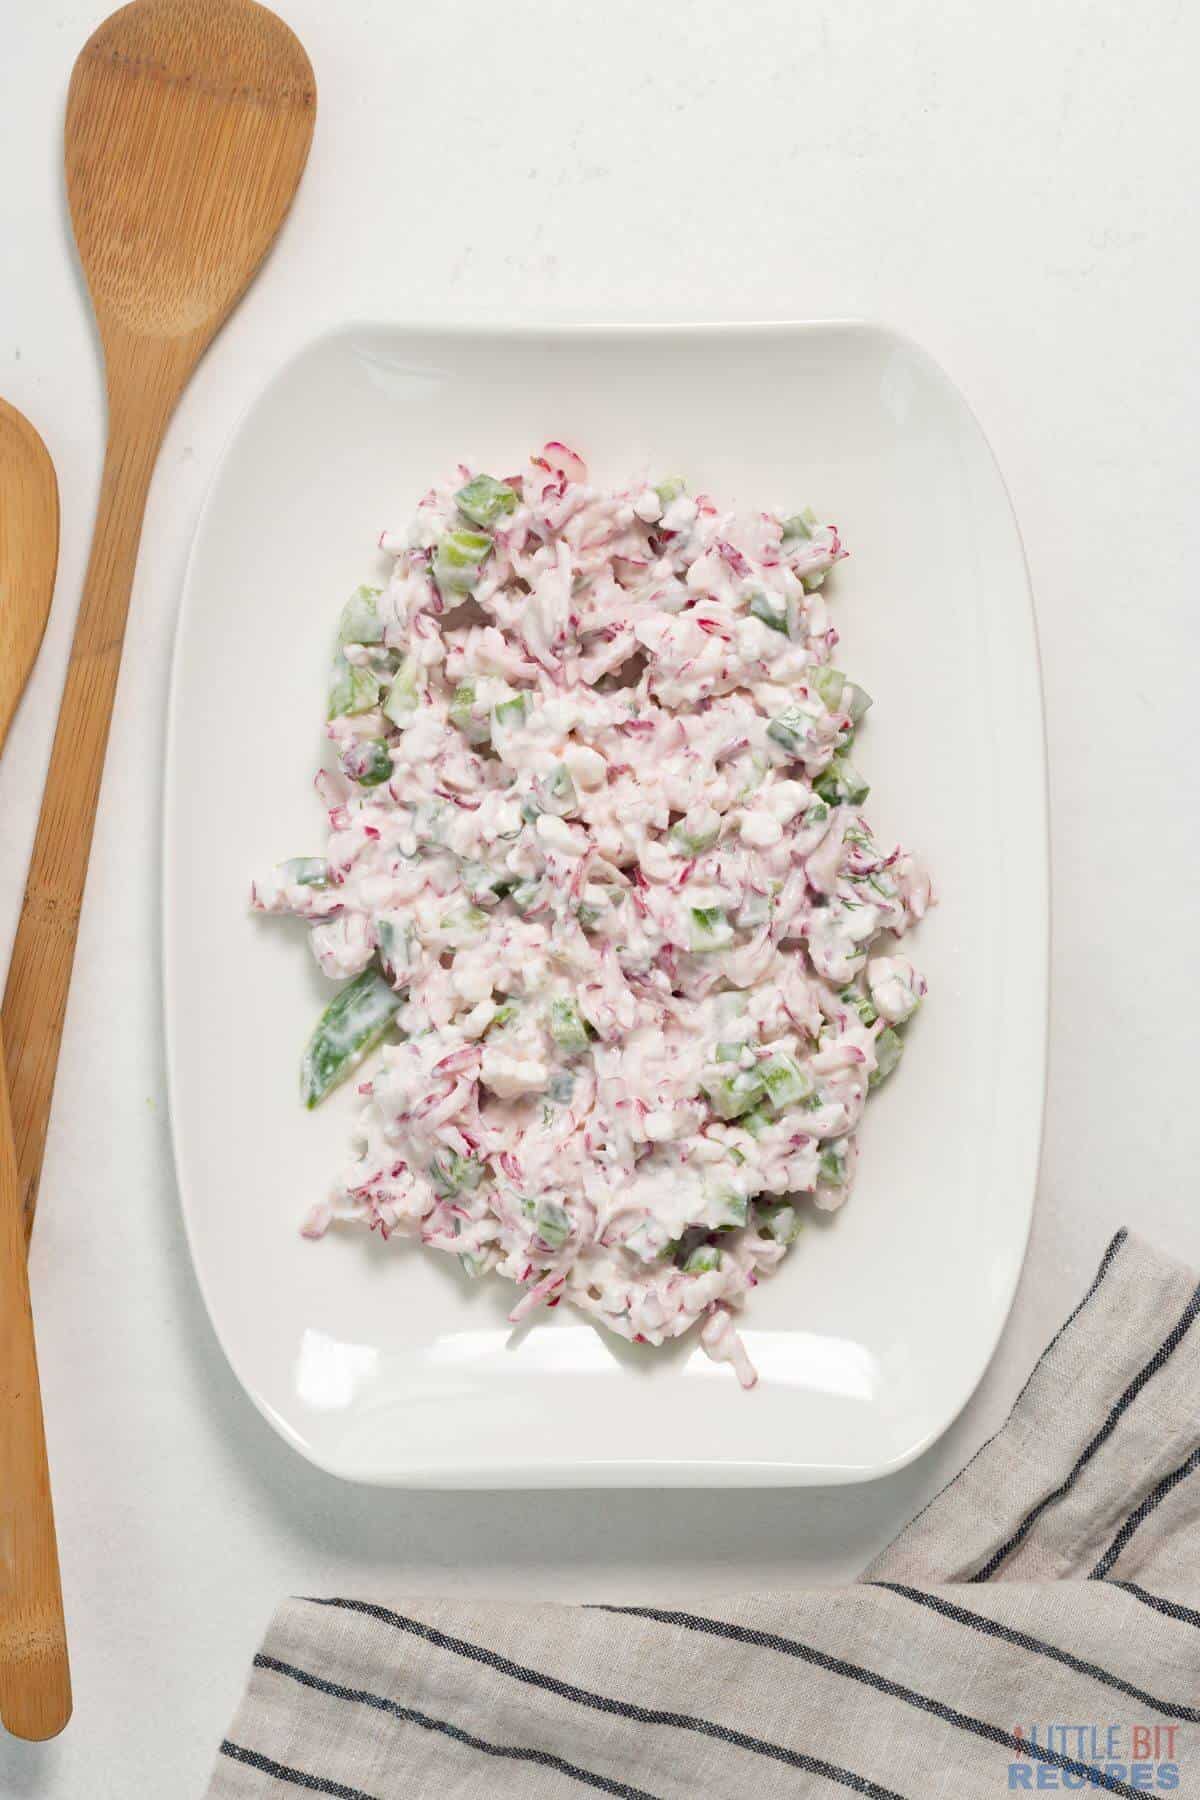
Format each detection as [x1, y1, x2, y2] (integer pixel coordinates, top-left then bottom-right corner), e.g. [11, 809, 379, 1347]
[0, 400, 70, 1737]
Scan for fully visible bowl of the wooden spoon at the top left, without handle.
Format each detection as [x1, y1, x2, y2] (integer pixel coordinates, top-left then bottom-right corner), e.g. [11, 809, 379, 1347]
[67, 0, 317, 360]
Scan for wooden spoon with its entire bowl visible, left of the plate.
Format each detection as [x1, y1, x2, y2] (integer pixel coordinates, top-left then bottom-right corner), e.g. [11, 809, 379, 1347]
[4, 0, 317, 1229]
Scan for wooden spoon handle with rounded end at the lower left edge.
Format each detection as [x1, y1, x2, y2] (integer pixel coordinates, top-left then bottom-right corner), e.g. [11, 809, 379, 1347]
[0, 1048, 70, 1739]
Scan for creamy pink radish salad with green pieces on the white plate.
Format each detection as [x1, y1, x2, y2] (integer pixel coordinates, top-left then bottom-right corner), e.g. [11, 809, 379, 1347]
[252, 445, 930, 1384]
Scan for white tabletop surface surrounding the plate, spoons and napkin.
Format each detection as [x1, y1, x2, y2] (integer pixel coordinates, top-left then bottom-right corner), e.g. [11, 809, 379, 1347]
[0, 0, 1200, 1800]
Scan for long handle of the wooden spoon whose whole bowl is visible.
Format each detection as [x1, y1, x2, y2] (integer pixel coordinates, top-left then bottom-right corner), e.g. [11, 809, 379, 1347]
[4, 358, 181, 1238]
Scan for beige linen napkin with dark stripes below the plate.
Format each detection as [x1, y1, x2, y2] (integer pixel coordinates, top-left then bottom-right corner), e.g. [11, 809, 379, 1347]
[209, 1231, 1200, 1800]
